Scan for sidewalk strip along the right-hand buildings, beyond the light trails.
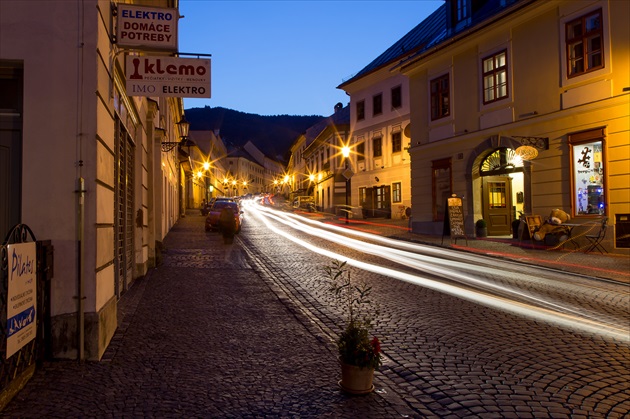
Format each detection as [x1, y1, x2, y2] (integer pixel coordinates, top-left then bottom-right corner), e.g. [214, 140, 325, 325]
[304, 213, 630, 284]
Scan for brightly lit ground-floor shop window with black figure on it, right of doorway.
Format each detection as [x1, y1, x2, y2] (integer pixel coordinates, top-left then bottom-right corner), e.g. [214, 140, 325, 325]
[569, 128, 606, 215]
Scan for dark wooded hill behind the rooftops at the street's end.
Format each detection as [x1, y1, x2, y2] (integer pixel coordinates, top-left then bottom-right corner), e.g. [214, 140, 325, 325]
[186, 106, 324, 163]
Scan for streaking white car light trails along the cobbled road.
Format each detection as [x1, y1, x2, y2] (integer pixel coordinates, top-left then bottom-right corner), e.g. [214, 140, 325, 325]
[251, 203, 630, 343]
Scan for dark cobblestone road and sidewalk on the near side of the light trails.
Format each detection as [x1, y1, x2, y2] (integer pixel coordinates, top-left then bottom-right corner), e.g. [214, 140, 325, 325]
[2, 213, 630, 418]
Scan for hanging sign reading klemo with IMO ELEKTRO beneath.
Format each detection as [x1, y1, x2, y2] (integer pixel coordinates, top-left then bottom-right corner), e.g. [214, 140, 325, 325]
[125, 56, 210, 98]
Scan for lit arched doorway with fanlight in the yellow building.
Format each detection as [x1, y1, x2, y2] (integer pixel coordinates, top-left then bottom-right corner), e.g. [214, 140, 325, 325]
[479, 147, 524, 236]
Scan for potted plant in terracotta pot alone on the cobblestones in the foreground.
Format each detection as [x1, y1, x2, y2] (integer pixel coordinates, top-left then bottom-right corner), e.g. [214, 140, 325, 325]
[326, 261, 382, 394]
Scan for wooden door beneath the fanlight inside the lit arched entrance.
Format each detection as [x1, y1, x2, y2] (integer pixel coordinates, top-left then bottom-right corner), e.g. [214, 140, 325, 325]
[483, 176, 512, 236]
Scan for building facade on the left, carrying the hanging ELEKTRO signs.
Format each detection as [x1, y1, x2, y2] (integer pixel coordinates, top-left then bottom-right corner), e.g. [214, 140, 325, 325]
[0, 0, 198, 360]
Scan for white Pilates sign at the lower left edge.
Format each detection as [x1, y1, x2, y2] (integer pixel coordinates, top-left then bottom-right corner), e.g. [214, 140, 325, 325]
[6, 243, 37, 359]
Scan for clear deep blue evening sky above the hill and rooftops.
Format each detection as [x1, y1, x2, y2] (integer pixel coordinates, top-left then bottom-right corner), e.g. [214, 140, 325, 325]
[179, 0, 444, 116]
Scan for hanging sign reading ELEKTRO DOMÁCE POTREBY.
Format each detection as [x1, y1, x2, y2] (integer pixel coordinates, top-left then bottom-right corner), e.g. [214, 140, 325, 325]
[116, 3, 179, 51]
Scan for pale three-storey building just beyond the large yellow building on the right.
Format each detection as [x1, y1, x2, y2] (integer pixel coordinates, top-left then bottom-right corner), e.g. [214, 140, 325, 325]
[339, 55, 418, 219]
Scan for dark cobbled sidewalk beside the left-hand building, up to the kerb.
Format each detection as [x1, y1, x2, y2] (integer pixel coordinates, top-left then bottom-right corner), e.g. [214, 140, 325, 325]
[0, 212, 409, 418]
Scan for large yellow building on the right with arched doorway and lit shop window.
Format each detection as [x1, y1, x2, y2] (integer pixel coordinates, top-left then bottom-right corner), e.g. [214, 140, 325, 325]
[396, 0, 630, 253]
